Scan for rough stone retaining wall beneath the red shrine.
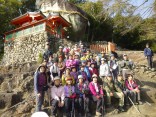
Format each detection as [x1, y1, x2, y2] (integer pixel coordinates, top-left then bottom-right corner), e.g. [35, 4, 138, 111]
[2, 32, 48, 65]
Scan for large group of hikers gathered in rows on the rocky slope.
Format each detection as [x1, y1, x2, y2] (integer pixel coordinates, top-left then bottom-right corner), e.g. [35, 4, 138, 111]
[34, 43, 142, 117]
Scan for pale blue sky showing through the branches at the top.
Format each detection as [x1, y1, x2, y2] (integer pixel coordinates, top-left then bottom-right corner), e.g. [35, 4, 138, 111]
[90, 0, 155, 19]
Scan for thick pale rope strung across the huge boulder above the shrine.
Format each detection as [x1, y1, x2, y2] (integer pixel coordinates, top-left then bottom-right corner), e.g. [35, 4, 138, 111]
[43, 10, 88, 20]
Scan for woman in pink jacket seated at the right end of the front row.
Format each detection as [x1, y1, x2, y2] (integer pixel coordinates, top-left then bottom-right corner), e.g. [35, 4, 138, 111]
[125, 74, 142, 104]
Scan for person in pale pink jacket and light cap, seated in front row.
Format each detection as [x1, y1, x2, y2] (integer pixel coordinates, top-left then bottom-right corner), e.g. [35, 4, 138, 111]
[51, 76, 65, 117]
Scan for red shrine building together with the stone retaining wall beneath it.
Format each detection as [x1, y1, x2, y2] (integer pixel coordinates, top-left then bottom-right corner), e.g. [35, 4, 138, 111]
[2, 12, 71, 65]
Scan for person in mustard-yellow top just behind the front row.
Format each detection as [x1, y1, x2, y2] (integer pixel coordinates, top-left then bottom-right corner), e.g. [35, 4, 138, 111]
[62, 67, 75, 85]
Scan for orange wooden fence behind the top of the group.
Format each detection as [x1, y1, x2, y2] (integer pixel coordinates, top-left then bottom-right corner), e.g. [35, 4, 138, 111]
[90, 42, 116, 53]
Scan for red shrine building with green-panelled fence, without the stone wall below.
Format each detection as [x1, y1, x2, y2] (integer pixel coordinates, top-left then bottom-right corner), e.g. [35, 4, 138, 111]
[5, 12, 70, 43]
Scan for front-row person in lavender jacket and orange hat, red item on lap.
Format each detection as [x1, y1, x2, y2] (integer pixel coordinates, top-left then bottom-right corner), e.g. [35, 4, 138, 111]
[64, 77, 76, 117]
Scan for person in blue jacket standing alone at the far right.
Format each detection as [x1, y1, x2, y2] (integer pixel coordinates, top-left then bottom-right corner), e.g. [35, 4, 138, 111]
[144, 44, 154, 69]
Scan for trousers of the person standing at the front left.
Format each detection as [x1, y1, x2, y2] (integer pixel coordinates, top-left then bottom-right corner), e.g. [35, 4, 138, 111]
[36, 91, 44, 112]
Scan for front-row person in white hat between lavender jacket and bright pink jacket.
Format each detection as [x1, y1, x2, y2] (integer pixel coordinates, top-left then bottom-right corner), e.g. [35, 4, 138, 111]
[75, 75, 91, 117]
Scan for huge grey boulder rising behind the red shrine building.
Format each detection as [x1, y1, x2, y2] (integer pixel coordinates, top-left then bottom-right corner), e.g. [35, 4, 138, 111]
[36, 0, 88, 41]
